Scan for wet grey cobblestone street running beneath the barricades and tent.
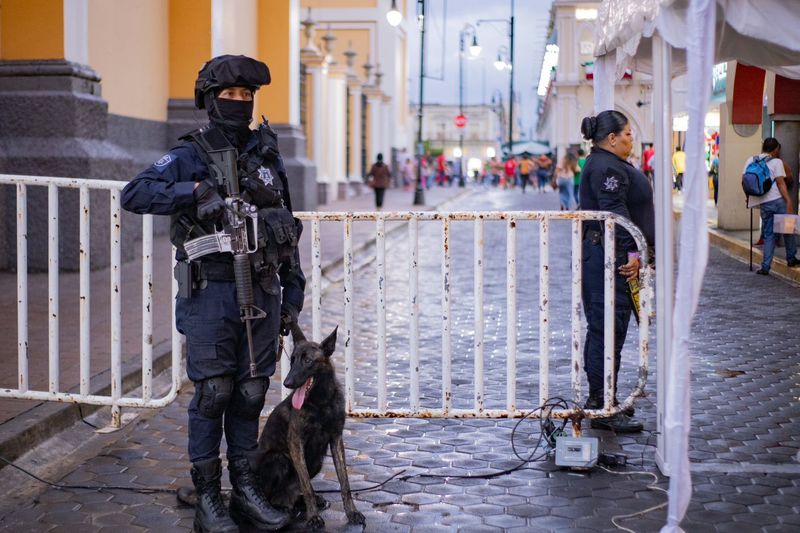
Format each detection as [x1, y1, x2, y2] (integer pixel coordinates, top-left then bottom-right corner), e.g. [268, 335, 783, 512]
[0, 189, 800, 533]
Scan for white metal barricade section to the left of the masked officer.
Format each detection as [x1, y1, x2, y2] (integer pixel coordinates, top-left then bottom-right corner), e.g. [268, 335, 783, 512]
[0, 174, 183, 427]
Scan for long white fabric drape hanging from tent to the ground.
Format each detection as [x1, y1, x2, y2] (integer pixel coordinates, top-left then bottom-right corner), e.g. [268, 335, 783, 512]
[661, 0, 717, 533]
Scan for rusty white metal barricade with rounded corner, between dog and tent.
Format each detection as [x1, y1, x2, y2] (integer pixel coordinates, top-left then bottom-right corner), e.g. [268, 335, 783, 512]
[294, 211, 652, 426]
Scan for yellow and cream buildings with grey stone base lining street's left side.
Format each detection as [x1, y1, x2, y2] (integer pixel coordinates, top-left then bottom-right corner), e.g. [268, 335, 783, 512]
[0, 0, 408, 270]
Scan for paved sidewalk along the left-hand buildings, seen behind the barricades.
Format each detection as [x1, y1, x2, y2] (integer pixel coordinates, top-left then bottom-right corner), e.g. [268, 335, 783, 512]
[0, 183, 468, 458]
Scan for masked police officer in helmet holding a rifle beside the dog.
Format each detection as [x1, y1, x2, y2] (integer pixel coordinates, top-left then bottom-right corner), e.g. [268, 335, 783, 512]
[122, 55, 305, 532]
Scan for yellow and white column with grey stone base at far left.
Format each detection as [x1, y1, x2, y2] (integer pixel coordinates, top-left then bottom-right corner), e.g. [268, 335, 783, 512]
[0, 0, 140, 271]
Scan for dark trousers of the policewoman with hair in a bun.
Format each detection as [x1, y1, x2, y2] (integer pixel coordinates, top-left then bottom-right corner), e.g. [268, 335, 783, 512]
[581, 239, 631, 397]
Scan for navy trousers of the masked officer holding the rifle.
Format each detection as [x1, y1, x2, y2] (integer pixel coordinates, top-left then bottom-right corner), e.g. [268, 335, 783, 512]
[175, 280, 280, 462]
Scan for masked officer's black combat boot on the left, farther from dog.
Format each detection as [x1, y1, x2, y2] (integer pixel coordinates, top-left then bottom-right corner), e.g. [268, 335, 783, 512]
[192, 459, 239, 533]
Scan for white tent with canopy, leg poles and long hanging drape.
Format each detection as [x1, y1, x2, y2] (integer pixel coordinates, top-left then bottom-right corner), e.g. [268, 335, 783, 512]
[594, 0, 800, 533]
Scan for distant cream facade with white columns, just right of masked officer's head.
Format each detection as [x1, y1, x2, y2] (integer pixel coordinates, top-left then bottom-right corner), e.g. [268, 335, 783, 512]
[301, 0, 414, 202]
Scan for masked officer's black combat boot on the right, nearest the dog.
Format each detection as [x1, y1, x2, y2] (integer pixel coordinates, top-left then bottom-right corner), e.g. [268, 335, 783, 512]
[228, 457, 291, 531]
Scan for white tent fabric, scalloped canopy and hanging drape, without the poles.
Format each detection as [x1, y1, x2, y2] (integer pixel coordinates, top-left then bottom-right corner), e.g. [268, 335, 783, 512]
[595, 0, 800, 533]
